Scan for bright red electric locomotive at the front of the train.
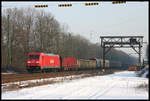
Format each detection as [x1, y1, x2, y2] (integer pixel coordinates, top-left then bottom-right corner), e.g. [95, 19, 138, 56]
[27, 53, 61, 72]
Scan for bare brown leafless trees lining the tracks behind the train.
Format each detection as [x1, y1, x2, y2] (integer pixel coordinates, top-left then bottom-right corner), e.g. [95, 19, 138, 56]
[1, 8, 137, 71]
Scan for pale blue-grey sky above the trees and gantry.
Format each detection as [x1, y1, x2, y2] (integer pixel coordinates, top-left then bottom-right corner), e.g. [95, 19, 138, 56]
[2, 1, 149, 59]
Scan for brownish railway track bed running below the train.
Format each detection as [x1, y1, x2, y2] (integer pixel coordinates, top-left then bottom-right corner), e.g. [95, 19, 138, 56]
[1, 70, 123, 84]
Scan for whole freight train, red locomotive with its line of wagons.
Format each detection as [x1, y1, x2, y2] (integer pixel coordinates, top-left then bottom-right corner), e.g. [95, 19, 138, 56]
[27, 53, 121, 72]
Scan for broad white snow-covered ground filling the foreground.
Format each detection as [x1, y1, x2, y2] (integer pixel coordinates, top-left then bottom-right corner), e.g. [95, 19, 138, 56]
[1, 71, 149, 99]
